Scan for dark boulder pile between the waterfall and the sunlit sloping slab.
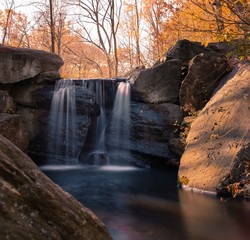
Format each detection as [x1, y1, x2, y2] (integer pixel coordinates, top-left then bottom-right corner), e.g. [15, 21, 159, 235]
[130, 39, 234, 167]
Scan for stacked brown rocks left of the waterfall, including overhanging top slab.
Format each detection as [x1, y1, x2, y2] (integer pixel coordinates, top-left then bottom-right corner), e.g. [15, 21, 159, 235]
[0, 45, 63, 150]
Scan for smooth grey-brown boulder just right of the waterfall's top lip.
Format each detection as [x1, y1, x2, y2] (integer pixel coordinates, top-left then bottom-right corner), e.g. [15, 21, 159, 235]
[132, 60, 182, 104]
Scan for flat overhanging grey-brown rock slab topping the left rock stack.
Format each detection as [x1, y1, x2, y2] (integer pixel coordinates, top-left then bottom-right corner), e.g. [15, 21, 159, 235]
[0, 44, 63, 84]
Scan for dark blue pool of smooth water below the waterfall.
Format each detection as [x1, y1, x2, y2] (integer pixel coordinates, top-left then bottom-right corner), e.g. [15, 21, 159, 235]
[41, 165, 250, 240]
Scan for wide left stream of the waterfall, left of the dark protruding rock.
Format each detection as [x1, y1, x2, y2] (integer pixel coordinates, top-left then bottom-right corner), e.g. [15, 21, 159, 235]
[48, 80, 78, 164]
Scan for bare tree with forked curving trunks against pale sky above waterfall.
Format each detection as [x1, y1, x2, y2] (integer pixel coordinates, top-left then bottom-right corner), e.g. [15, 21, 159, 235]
[68, 0, 122, 77]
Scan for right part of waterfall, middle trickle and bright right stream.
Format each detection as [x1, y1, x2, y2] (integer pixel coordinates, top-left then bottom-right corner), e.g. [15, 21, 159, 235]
[81, 80, 130, 165]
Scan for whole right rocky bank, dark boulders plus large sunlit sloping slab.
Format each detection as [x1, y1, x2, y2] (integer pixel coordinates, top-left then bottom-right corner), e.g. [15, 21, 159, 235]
[130, 40, 250, 199]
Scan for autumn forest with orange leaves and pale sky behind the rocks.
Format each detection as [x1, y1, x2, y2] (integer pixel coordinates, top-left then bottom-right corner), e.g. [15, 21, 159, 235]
[0, 0, 250, 78]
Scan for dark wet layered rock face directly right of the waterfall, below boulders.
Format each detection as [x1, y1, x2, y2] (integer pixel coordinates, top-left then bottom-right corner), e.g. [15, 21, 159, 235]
[122, 102, 179, 166]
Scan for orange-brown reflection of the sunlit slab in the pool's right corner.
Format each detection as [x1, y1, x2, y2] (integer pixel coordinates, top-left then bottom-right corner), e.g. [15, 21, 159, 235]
[179, 191, 250, 240]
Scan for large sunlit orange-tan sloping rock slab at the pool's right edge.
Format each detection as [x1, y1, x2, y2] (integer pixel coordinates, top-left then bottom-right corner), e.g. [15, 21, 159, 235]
[178, 63, 250, 199]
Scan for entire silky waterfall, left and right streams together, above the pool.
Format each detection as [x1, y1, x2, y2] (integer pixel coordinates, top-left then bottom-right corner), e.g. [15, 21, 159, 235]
[48, 80, 130, 165]
